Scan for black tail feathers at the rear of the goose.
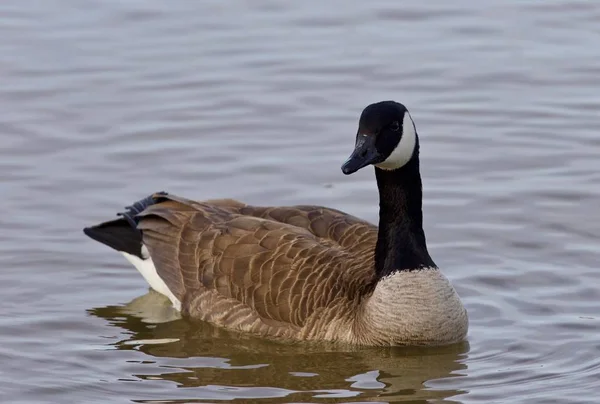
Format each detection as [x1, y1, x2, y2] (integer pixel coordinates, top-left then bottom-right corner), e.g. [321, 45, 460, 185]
[83, 192, 168, 259]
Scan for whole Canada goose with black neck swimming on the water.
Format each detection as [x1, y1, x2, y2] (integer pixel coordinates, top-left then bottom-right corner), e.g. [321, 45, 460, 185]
[84, 101, 468, 345]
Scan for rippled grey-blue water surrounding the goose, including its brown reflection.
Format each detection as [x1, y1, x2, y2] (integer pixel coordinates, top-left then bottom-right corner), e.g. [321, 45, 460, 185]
[0, 0, 600, 403]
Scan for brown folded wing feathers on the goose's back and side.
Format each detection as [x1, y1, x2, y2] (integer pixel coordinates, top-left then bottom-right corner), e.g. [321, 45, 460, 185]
[138, 195, 376, 334]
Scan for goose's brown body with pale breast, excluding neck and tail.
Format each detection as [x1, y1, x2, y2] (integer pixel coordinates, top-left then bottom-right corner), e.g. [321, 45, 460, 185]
[123, 194, 466, 345]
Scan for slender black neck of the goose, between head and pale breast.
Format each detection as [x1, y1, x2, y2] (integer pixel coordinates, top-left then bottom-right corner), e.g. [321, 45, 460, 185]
[375, 143, 435, 279]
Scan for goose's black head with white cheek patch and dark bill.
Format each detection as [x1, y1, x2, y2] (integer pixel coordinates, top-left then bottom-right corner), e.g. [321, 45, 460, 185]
[342, 101, 417, 174]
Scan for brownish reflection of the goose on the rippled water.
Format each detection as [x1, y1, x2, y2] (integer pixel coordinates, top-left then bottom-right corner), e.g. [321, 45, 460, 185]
[89, 292, 469, 402]
